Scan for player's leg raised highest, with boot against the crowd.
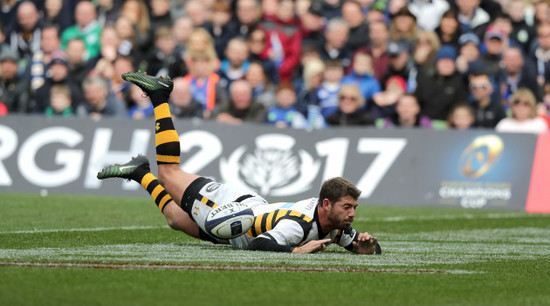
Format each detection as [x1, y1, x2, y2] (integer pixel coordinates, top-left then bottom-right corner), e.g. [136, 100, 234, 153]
[122, 72, 199, 206]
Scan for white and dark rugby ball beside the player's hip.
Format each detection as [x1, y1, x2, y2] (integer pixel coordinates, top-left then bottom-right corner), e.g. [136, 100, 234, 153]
[204, 202, 254, 239]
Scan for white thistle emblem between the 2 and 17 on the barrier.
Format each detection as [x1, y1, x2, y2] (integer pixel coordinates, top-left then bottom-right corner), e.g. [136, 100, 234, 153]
[220, 134, 321, 196]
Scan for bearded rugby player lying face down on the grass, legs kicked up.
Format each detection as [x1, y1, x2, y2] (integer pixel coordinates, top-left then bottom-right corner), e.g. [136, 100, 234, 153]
[97, 72, 382, 254]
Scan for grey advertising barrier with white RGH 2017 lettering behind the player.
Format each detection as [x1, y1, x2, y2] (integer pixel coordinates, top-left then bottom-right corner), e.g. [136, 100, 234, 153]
[0, 116, 550, 213]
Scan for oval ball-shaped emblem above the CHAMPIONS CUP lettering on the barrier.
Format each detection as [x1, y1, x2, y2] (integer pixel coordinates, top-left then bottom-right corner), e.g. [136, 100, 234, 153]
[459, 135, 504, 179]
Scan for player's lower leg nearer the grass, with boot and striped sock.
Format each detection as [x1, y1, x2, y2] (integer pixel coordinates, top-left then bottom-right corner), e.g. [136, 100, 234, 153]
[97, 155, 200, 238]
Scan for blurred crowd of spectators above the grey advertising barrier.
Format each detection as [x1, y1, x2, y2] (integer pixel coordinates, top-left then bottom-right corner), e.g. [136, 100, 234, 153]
[0, 0, 550, 133]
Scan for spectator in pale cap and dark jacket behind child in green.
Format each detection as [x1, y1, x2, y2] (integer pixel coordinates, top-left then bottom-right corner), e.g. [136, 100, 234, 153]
[29, 50, 83, 114]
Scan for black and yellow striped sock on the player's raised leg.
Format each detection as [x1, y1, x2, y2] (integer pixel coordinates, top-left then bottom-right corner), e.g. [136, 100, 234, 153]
[155, 103, 181, 164]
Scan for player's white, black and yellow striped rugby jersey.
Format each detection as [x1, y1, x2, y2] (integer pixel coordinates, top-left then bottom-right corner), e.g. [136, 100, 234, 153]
[229, 198, 358, 250]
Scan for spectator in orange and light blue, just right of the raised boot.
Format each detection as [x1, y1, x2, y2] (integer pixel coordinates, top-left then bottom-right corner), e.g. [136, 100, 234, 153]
[184, 49, 227, 118]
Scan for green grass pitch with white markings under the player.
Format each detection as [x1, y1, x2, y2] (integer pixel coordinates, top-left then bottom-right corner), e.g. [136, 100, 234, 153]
[0, 193, 550, 306]
